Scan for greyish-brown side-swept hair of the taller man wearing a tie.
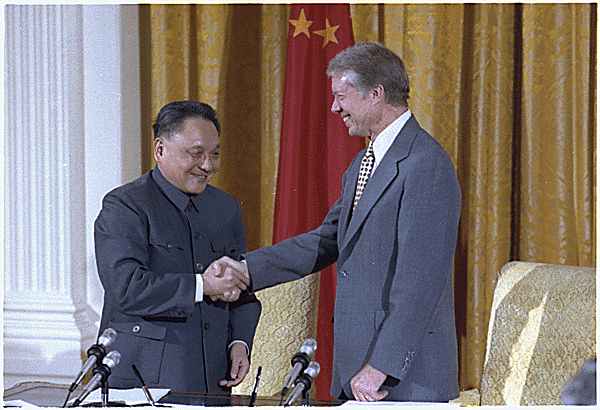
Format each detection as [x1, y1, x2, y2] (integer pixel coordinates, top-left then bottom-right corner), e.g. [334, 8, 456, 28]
[327, 42, 410, 107]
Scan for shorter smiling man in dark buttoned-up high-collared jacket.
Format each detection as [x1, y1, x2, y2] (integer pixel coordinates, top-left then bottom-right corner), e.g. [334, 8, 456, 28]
[94, 101, 261, 393]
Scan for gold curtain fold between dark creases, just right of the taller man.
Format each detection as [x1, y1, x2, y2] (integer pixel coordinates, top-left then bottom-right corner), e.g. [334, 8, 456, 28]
[455, 5, 514, 387]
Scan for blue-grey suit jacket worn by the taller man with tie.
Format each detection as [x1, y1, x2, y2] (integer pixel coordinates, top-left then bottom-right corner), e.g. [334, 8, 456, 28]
[244, 116, 461, 401]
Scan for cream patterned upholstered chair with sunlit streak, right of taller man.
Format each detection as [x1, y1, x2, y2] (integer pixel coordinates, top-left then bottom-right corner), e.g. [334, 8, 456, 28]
[457, 262, 596, 406]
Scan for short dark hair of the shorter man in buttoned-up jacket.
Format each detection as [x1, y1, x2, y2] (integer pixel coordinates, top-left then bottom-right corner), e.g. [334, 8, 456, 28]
[152, 101, 221, 139]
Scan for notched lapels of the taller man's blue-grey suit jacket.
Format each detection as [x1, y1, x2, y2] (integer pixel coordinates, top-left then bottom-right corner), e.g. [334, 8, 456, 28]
[341, 115, 420, 251]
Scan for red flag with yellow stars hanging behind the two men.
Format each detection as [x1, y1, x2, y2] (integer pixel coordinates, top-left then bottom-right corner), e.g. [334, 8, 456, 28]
[273, 4, 365, 400]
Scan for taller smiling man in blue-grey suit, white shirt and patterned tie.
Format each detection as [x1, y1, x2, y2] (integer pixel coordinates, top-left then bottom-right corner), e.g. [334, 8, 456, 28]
[215, 43, 461, 402]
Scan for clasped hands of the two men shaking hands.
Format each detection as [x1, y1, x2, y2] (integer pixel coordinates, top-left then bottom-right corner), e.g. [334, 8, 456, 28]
[201, 256, 250, 302]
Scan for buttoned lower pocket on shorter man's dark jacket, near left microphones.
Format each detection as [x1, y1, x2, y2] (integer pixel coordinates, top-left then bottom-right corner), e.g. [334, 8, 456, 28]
[109, 321, 167, 383]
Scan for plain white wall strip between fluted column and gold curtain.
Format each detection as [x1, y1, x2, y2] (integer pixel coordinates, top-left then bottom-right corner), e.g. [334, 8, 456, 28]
[83, 5, 142, 322]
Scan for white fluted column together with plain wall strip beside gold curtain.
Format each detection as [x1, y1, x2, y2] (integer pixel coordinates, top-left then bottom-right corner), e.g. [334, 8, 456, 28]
[3, 5, 140, 388]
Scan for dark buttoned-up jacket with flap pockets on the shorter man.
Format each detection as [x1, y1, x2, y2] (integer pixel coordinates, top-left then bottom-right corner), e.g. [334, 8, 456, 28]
[94, 168, 261, 393]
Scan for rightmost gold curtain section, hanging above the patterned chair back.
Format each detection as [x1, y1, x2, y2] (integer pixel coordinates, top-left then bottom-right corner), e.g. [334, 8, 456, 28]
[515, 4, 596, 266]
